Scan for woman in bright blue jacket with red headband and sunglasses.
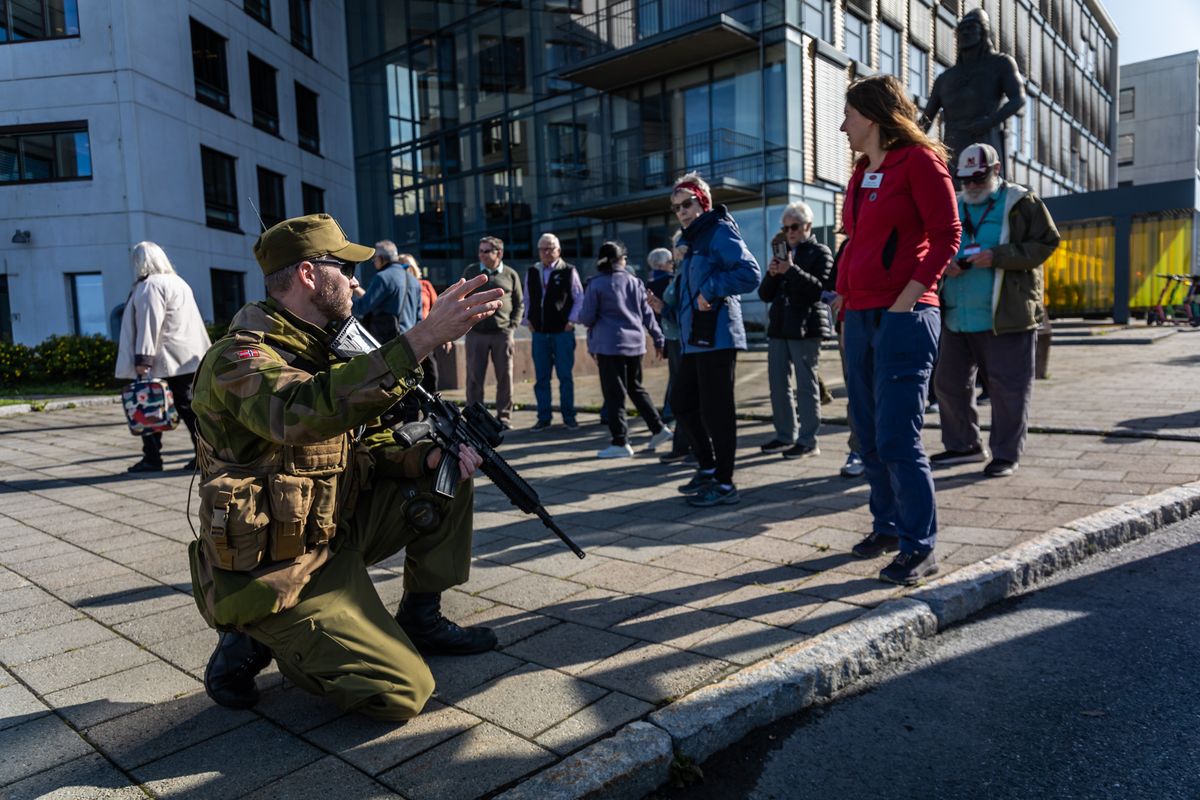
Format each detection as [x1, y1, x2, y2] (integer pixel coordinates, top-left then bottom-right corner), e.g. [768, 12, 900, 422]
[671, 173, 760, 506]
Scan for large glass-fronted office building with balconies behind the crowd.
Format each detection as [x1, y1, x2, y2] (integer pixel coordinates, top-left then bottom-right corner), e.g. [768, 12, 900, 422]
[347, 0, 1117, 293]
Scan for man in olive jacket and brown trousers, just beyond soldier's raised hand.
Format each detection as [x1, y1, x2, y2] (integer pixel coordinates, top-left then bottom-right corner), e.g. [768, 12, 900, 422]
[462, 236, 524, 428]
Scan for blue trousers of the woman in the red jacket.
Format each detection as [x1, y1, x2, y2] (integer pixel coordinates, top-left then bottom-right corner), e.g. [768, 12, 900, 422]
[842, 305, 941, 554]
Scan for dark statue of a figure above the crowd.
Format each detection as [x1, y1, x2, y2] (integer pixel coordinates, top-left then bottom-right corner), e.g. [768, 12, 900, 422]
[922, 8, 1025, 175]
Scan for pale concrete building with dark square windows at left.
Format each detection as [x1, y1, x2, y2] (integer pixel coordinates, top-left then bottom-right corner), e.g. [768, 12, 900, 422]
[0, 0, 356, 343]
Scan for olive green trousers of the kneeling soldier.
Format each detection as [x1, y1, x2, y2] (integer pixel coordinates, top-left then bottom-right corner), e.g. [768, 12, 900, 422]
[246, 476, 474, 720]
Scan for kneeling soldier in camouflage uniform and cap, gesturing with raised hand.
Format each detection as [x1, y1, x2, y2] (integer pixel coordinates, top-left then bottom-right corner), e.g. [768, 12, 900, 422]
[190, 213, 500, 720]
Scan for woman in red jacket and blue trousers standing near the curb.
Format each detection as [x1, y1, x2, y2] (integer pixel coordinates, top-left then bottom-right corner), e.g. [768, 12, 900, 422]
[834, 76, 960, 585]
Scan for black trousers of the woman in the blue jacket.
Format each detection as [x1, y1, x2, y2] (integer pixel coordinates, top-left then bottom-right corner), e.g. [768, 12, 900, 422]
[671, 349, 738, 483]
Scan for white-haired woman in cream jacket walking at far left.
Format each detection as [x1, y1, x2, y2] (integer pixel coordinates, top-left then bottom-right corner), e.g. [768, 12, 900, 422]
[116, 241, 212, 473]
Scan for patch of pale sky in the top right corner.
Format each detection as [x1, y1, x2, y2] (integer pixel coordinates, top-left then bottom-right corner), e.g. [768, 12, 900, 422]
[1102, 0, 1200, 64]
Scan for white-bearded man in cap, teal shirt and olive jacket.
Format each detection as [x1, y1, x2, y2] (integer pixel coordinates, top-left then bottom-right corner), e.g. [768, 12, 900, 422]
[929, 143, 1060, 477]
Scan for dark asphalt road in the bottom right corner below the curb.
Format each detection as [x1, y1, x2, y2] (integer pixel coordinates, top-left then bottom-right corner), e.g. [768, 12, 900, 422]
[658, 516, 1200, 800]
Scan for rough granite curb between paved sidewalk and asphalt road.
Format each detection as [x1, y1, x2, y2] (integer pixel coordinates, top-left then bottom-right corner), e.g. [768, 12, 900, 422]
[498, 481, 1200, 800]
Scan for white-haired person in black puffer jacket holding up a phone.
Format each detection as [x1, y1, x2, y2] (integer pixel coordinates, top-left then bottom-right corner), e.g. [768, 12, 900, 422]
[758, 201, 833, 458]
